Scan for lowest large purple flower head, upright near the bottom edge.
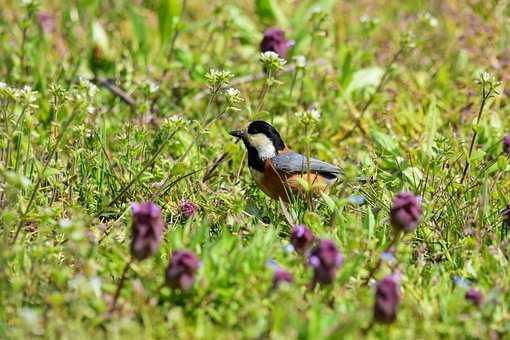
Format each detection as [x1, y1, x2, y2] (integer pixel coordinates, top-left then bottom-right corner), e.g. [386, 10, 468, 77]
[374, 275, 400, 323]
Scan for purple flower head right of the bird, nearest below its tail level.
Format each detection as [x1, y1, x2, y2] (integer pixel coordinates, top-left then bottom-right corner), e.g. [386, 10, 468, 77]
[390, 192, 422, 232]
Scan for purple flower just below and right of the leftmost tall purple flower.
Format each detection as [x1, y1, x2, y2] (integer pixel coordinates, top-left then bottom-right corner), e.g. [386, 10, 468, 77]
[166, 250, 200, 292]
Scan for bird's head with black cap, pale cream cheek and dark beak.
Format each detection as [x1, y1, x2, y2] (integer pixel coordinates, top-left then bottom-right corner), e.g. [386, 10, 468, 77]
[230, 120, 285, 160]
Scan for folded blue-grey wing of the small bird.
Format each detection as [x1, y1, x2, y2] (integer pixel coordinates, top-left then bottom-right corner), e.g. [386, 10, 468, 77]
[271, 152, 342, 178]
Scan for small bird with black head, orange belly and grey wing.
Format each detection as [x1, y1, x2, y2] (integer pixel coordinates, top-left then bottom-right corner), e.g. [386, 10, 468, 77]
[230, 120, 342, 202]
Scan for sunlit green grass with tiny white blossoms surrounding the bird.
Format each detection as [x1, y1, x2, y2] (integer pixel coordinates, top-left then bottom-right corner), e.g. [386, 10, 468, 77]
[0, 0, 510, 339]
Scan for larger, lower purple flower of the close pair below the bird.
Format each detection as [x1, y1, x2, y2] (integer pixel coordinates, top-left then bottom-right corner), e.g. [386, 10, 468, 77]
[308, 240, 343, 285]
